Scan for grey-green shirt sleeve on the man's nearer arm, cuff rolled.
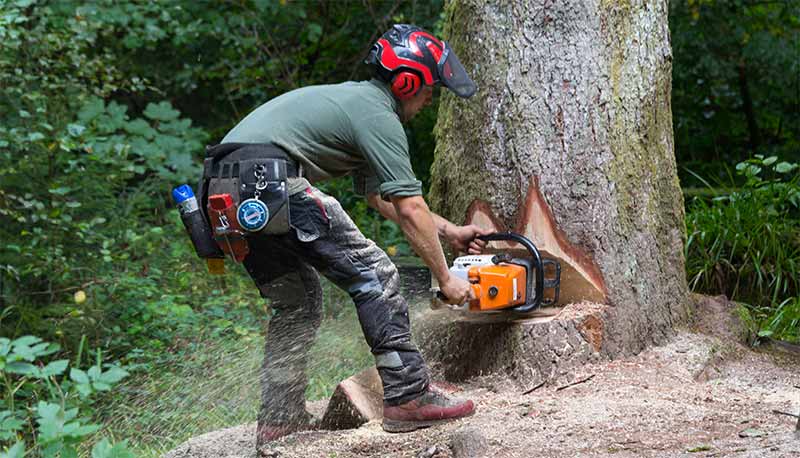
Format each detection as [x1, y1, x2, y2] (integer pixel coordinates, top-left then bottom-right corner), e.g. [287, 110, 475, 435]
[354, 113, 422, 200]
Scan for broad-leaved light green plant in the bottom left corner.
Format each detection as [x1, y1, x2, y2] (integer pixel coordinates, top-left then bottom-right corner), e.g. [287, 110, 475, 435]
[0, 336, 131, 458]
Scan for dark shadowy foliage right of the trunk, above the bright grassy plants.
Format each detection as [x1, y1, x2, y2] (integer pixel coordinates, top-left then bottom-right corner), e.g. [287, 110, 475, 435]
[669, 0, 800, 186]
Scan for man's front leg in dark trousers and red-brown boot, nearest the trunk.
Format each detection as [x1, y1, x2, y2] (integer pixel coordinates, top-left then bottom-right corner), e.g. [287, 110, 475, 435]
[292, 190, 475, 432]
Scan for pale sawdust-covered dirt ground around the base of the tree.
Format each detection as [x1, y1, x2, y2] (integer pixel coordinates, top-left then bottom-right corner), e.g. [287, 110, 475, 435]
[166, 298, 800, 458]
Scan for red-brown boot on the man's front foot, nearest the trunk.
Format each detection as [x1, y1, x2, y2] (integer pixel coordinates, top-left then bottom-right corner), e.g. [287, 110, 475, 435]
[383, 385, 475, 433]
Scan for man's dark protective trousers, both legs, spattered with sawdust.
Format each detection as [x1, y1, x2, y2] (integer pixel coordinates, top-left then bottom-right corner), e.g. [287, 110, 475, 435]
[244, 188, 429, 424]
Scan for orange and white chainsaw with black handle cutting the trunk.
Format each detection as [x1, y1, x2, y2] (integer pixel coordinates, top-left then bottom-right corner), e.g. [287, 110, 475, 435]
[434, 232, 561, 313]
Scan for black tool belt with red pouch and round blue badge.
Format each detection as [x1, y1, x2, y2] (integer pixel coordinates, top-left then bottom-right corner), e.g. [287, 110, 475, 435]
[198, 143, 301, 245]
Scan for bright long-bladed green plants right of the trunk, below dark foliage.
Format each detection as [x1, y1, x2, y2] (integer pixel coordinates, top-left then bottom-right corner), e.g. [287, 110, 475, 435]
[686, 155, 800, 339]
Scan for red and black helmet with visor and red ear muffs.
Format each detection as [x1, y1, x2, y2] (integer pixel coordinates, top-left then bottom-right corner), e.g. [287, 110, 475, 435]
[366, 24, 476, 100]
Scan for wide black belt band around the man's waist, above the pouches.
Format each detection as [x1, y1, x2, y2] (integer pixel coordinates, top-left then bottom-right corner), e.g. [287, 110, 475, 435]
[203, 143, 302, 178]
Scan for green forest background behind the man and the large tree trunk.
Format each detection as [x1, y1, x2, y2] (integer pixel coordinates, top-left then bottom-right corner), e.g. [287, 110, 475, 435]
[0, 0, 800, 457]
